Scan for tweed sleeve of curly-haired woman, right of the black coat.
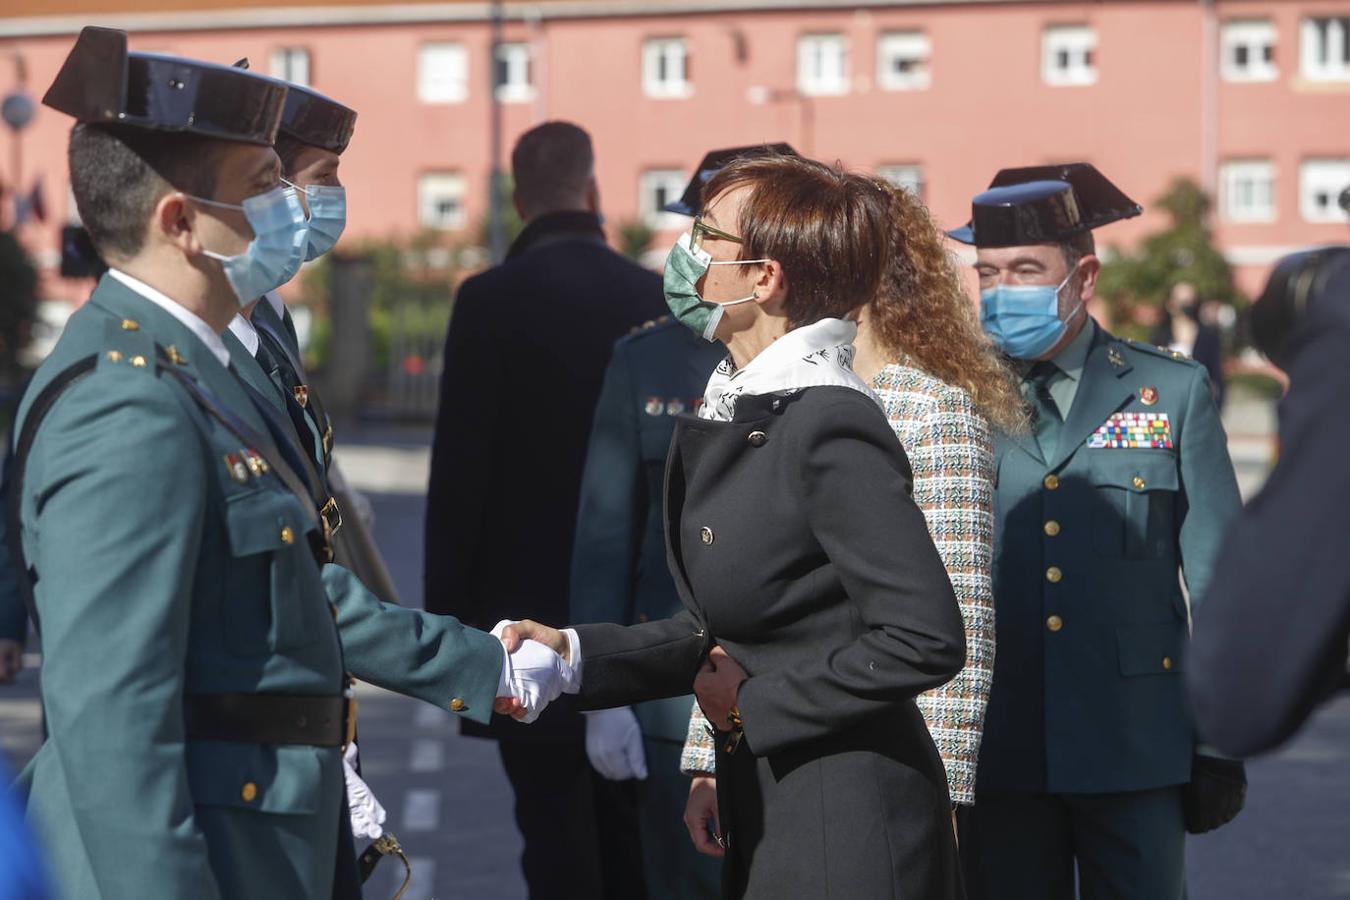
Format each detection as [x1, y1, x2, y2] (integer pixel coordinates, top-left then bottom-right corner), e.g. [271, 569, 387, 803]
[906, 394, 994, 804]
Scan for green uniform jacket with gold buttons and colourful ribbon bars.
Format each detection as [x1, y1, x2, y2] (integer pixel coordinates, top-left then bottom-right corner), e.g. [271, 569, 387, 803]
[977, 322, 1241, 793]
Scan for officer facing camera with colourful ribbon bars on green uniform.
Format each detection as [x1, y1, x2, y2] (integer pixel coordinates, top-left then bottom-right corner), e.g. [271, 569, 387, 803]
[952, 163, 1239, 900]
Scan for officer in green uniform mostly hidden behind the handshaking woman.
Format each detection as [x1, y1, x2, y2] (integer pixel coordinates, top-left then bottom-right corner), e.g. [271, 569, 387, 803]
[570, 144, 797, 900]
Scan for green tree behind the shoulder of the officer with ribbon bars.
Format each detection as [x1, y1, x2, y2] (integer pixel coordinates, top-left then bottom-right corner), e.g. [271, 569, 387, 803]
[1096, 178, 1246, 336]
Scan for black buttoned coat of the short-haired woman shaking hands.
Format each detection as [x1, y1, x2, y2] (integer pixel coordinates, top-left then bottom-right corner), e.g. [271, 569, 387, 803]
[578, 387, 965, 900]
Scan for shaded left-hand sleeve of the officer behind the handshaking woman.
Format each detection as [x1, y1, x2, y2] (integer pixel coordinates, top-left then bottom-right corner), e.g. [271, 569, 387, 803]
[568, 347, 647, 623]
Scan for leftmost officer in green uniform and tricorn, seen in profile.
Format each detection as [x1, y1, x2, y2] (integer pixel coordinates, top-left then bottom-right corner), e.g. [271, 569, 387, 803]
[12, 28, 564, 900]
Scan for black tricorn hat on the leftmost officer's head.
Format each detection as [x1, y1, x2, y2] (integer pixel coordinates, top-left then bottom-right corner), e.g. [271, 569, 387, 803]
[42, 26, 286, 147]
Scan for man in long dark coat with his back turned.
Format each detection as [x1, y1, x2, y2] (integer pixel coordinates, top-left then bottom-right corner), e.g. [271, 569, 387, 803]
[425, 121, 666, 899]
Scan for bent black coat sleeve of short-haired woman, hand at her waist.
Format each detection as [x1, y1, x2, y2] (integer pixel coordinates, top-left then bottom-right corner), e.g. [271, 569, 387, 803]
[737, 395, 965, 756]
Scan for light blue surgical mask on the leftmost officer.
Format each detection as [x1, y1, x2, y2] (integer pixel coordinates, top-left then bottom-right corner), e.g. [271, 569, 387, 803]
[186, 185, 306, 308]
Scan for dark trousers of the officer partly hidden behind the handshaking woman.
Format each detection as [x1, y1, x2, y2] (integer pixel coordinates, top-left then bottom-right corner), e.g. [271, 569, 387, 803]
[639, 738, 722, 900]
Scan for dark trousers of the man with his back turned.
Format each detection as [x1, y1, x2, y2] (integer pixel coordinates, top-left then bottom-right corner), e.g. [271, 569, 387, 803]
[497, 739, 647, 900]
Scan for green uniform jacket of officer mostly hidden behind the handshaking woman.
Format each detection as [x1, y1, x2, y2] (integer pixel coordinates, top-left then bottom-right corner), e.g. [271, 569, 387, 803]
[570, 318, 726, 744]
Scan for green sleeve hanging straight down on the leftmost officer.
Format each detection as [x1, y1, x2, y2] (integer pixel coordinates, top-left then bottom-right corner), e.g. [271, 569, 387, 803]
[24, 377, 220, 900]
